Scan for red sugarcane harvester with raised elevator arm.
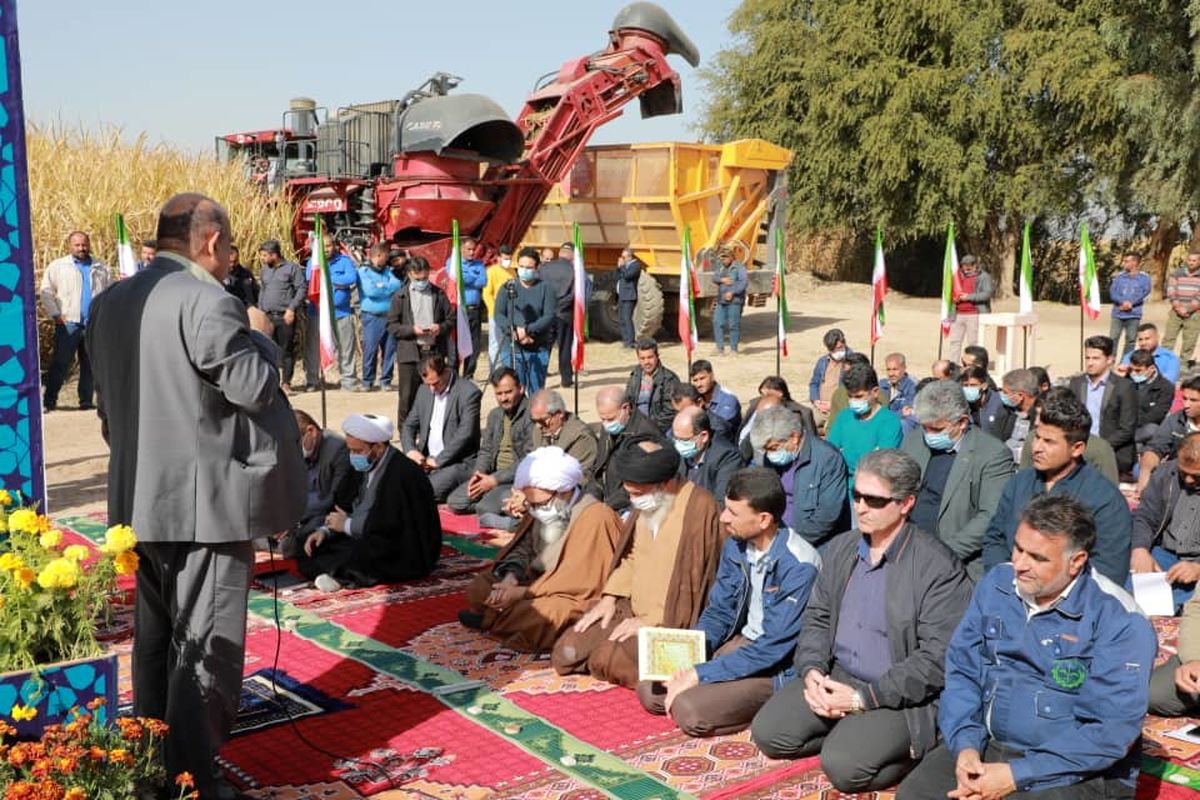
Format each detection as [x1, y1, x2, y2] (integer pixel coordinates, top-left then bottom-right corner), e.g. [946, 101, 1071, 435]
[217, 2, 700, 281]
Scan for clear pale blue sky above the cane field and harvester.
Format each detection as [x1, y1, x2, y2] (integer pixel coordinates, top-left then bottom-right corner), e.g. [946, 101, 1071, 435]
[18, 0, 738, 151]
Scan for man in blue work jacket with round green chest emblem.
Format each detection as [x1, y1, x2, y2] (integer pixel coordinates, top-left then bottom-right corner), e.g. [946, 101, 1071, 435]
[896, 495, 1158, 800]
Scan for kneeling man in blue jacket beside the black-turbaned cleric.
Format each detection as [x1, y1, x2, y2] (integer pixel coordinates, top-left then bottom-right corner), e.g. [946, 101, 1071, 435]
[637, 467, 821, 736]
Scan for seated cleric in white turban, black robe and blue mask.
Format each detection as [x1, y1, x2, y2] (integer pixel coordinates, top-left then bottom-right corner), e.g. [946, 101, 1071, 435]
[296, 414, 442, 591]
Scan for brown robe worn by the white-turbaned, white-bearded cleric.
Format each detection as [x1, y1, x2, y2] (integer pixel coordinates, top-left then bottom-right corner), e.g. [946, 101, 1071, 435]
[467, 495, 622, 652]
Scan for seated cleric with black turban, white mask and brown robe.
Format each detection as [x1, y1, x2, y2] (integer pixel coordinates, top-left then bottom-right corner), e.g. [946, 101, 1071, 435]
[551, 439, 724, 688]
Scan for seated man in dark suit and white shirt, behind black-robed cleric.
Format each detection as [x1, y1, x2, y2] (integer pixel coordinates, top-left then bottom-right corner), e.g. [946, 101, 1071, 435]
[400, 353, 484, 503]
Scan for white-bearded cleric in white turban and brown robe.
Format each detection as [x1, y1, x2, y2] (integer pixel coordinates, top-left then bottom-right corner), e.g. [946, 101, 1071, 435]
[458, 447, 620, 652]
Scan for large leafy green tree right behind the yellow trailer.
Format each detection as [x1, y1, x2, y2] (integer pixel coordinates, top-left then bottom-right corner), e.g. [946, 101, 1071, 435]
[702, 0, 1128, 294]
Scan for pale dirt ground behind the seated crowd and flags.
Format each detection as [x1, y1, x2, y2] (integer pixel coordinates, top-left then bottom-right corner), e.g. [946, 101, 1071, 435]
[44, 275, 1166, 515]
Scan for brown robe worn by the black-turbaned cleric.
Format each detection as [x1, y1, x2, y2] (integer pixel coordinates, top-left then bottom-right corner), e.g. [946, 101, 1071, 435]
[551, 482, 725, 688]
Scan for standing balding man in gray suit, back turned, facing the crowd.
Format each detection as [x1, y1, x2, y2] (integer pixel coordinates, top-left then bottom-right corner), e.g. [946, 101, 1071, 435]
[88, 194, 305, 800]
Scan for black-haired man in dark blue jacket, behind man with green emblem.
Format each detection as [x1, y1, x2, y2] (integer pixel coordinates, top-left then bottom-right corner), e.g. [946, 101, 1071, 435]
[983, 387, 1133, 587]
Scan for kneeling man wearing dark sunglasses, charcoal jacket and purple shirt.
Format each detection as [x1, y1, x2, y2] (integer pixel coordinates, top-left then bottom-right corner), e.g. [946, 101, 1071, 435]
[751, 450, 971, 793]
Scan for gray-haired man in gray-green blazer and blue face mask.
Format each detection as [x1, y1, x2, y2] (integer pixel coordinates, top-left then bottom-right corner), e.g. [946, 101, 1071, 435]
[900, 380, 1014, 581]
